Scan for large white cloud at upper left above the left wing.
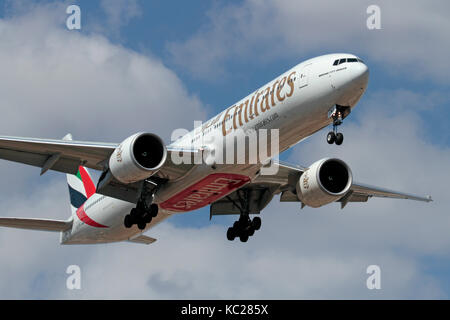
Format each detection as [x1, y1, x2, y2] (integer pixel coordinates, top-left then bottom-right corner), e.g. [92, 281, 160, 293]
[0, 2, 205, 141]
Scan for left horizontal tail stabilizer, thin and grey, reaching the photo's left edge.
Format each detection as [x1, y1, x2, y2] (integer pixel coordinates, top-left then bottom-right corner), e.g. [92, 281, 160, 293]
[0, 218, 72, 231]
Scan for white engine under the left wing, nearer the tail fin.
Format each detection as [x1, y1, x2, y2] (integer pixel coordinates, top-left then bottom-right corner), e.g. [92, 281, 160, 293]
[109, 133, 167, 184]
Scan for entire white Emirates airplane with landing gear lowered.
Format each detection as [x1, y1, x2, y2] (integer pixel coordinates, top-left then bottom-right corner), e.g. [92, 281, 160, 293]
[0, 53, 432, 244]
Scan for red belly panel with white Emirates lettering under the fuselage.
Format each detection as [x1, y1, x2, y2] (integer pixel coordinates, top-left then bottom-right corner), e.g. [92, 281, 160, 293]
[159, 173, 250, 212]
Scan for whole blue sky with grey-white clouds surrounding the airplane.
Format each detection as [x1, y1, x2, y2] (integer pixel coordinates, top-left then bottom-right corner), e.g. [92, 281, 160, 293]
[0, 0, 450, 298]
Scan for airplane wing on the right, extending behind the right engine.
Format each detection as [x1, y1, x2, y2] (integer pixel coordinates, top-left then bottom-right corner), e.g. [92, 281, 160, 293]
[210, 161, 432, 217]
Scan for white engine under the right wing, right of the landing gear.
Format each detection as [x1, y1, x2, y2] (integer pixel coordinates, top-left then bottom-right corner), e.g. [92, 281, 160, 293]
[296, 158, 353, 208]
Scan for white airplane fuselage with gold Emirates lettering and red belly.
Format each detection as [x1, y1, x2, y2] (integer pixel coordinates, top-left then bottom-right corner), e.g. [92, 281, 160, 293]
[61, 54, 368, 244]
